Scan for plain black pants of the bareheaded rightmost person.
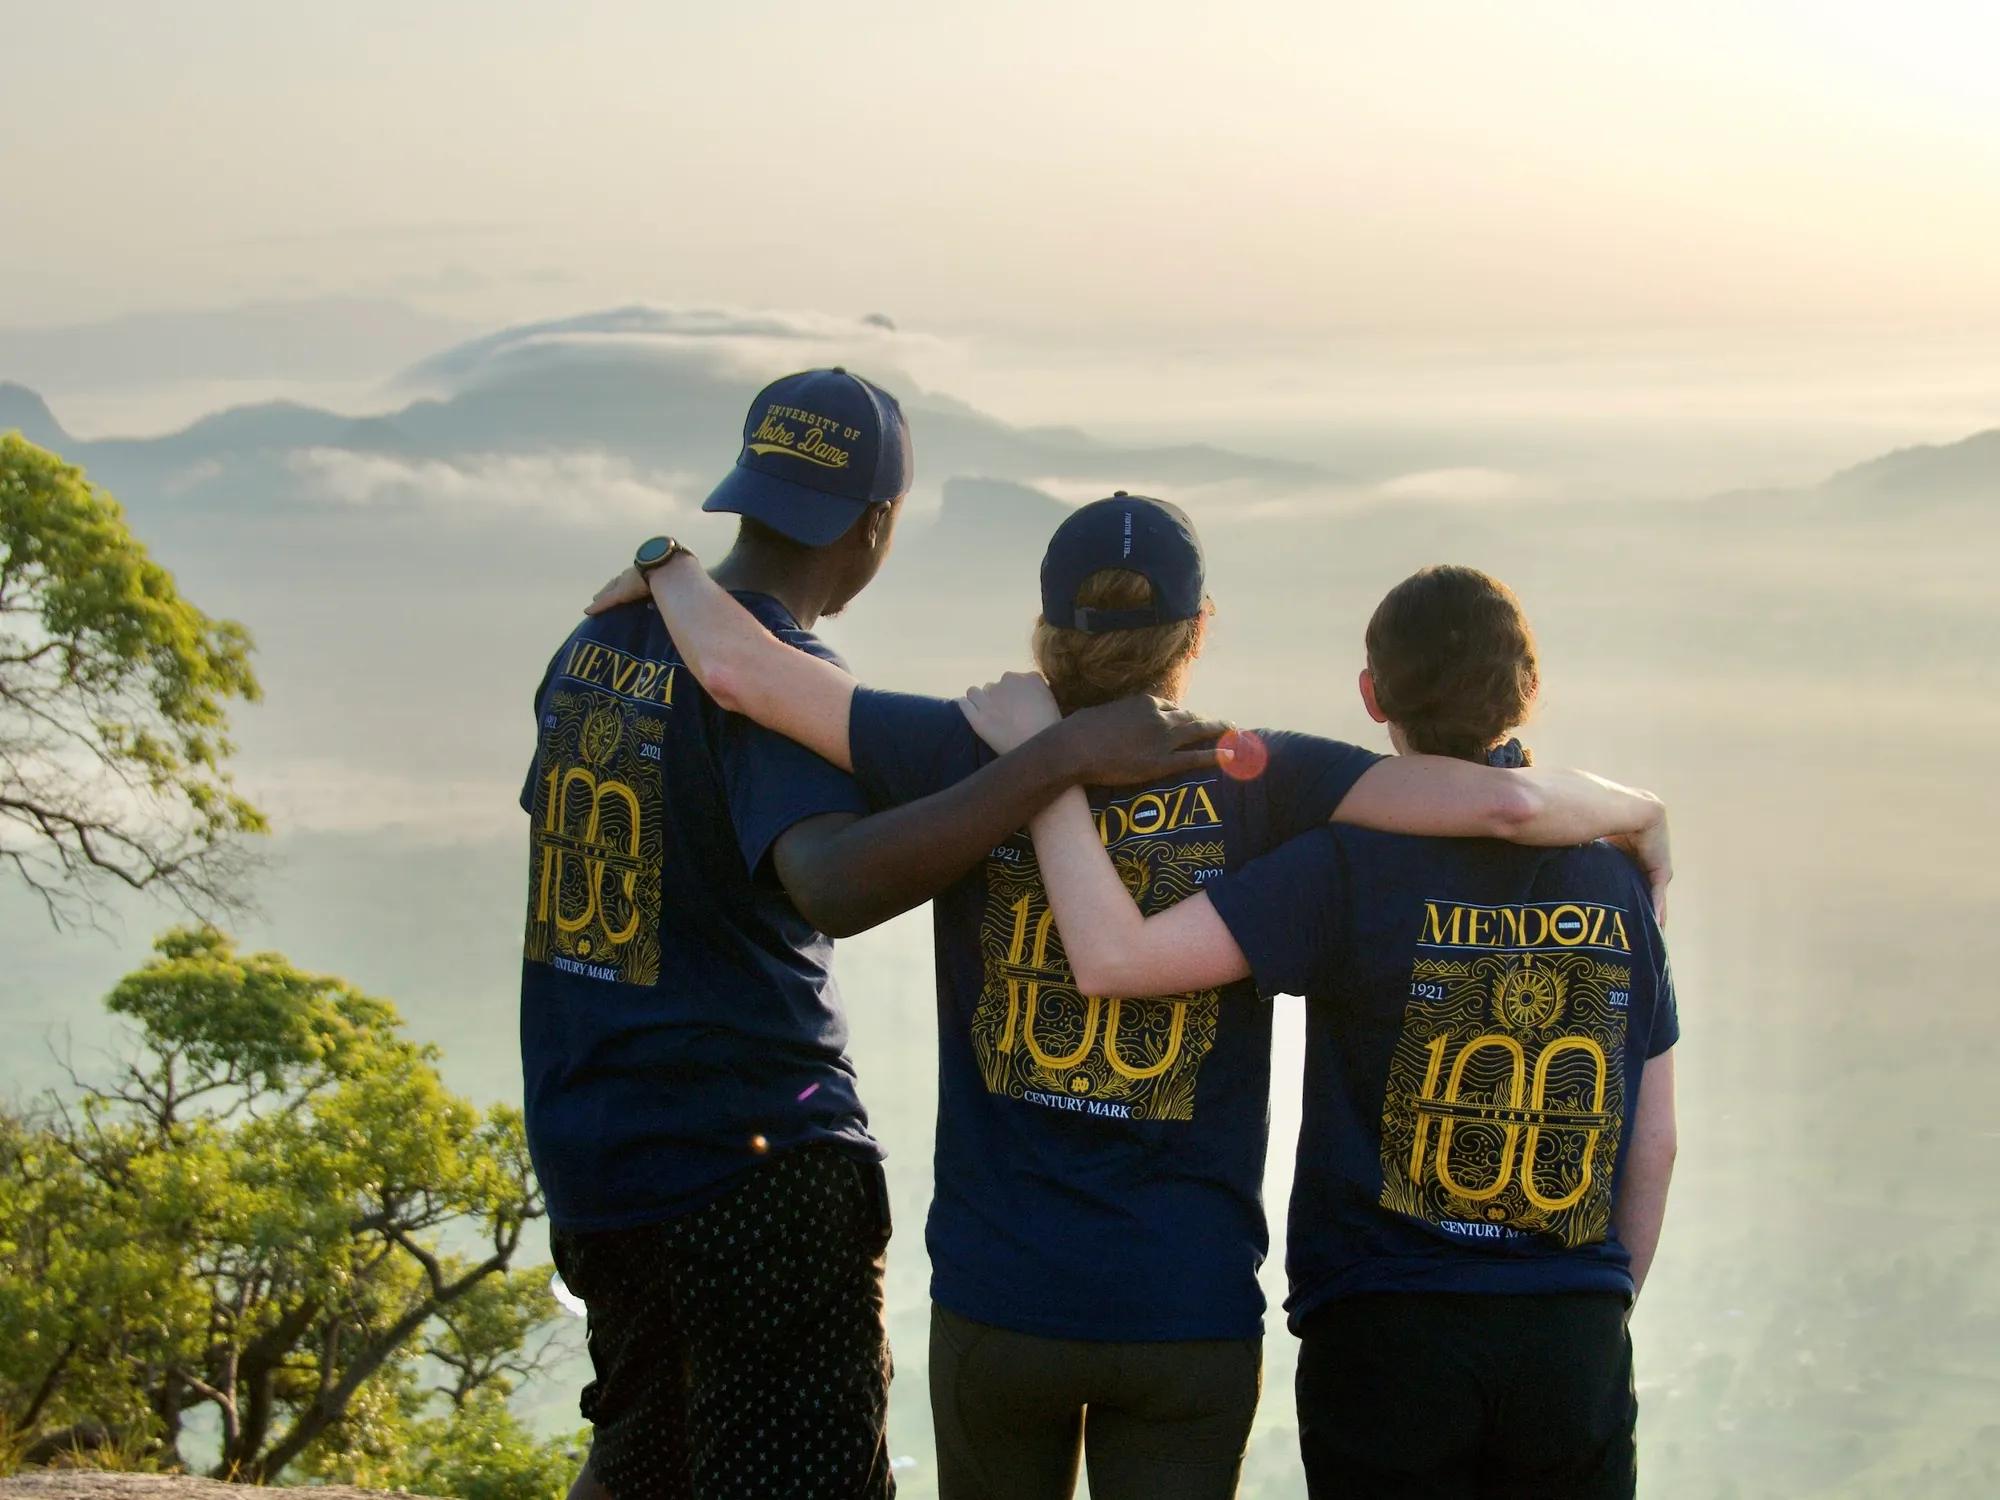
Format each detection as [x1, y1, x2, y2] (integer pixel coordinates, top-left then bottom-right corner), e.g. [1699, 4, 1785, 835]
[1298, 1292, 1638, 1500]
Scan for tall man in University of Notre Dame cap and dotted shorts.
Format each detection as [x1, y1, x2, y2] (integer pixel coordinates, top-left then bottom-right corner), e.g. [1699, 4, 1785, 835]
[520, 370, 1220, 1500]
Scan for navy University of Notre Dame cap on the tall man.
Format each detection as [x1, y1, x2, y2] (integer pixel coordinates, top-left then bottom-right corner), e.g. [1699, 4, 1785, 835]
[702, 368, 910, 546]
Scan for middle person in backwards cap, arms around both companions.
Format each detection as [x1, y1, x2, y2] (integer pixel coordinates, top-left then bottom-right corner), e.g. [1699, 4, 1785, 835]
[592, 492, 1658, 1500]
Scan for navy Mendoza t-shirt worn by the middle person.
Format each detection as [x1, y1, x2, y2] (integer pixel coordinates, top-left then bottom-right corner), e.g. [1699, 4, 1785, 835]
[852, 690, 1378, 1340]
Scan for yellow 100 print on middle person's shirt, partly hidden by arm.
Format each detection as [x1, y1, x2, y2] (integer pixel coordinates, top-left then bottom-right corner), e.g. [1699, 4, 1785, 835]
[972, 782, 1224, 1120]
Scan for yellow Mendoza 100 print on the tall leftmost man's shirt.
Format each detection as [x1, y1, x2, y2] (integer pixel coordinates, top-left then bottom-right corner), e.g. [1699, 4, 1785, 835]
[526, 642, 674, 984]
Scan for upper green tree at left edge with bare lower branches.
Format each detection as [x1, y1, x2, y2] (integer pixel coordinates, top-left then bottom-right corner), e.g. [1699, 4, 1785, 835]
[0, 432, 264, 922]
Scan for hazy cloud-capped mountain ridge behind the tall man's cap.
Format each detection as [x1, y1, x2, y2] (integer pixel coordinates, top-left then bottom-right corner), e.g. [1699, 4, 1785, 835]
[0, 308, 1334, 528]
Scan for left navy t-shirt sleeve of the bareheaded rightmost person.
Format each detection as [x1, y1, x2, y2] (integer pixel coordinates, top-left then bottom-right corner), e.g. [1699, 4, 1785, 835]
[1204, 828, 1350, 998]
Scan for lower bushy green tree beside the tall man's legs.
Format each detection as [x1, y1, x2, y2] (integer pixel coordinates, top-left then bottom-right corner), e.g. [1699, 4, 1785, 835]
[0, 928, 570, 1500]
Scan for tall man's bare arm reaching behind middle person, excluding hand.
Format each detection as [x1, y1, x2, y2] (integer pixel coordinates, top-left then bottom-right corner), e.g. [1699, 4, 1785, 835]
[780, 726, 1082, 938]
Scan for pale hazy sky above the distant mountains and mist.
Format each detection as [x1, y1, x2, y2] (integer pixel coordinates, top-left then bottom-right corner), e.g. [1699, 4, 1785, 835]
[0, 0, 2000, 342]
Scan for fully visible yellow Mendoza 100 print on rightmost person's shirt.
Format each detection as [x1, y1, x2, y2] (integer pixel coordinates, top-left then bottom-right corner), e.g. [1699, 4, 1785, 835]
[1382, 900, 1632, 1248]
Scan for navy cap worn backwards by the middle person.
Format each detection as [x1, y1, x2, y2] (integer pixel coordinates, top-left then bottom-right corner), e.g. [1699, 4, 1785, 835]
[1042, 490, 1206, 634]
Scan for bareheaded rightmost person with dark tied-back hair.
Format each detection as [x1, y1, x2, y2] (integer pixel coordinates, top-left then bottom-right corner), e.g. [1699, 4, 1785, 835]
[970, 568, 1680, 1500]
